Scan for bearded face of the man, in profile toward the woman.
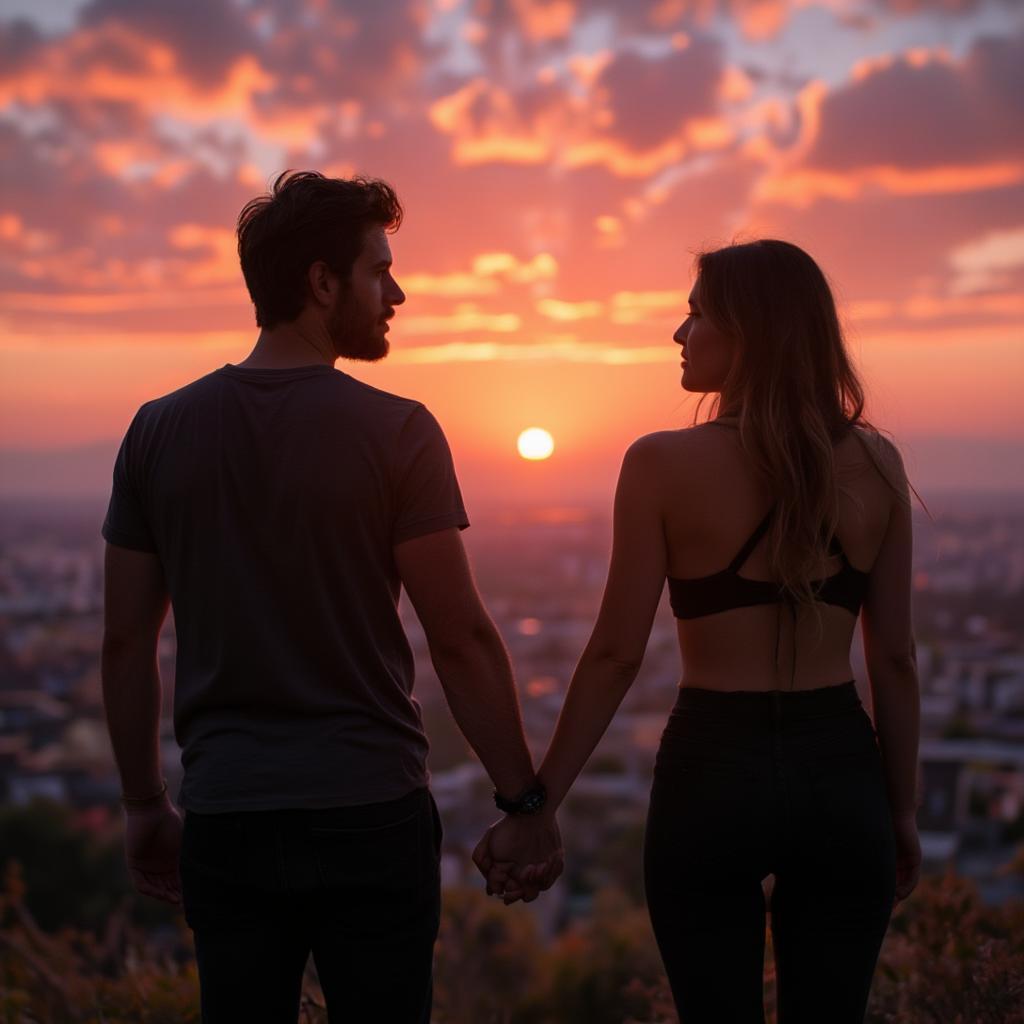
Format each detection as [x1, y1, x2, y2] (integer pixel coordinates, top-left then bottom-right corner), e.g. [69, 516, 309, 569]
[329, 227, 406, 362]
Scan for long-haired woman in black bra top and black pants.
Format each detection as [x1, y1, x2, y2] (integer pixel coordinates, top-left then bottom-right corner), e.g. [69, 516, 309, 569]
[481, 241, 921, 1024]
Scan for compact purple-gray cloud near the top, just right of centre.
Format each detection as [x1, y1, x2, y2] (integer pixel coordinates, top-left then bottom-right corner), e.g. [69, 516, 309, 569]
[597, 37, 723, 150]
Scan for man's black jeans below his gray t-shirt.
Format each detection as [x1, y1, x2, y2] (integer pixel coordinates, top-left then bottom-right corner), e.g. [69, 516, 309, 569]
[181, 788, 441, 1024]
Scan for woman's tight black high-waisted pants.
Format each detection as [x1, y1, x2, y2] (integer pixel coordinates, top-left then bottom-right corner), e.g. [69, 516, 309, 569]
[644, 682, 896, 1024]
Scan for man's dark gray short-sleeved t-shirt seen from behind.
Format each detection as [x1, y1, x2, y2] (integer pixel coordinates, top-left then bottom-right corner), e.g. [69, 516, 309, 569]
[102, 365, 469, 812]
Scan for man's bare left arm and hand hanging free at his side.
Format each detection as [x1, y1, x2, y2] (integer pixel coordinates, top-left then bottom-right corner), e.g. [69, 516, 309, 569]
[101, 544, 181, 903]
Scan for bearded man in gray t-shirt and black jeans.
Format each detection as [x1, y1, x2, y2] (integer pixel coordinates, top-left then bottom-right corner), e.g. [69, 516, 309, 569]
[102, 171, 561, 1024]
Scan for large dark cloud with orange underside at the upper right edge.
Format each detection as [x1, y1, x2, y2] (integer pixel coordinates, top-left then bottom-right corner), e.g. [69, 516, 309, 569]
[807, 28, 1024, 170]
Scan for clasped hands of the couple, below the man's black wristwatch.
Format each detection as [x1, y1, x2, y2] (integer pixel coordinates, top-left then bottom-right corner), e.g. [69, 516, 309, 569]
[473, 814, 564, 906]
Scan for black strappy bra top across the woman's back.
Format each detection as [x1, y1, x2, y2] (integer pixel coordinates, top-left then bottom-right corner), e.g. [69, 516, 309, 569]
[668, 507, 868, 618]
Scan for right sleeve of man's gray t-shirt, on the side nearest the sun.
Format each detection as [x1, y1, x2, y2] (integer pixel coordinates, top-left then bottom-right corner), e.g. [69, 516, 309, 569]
[391, 406, 469, 544]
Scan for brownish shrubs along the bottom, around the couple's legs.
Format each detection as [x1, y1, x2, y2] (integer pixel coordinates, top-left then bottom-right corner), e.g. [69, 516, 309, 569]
[0, 808, 1024, 1024]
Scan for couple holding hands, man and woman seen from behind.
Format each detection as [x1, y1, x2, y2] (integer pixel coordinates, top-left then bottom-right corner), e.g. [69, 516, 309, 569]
[102, 172, 921, 1024]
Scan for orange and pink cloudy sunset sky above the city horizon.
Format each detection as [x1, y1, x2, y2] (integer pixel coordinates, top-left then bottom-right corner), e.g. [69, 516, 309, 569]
[0, 0, 1024, 503]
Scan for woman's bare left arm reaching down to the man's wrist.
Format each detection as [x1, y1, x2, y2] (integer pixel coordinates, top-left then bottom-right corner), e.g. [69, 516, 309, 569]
[538, 434, 667, 817]
